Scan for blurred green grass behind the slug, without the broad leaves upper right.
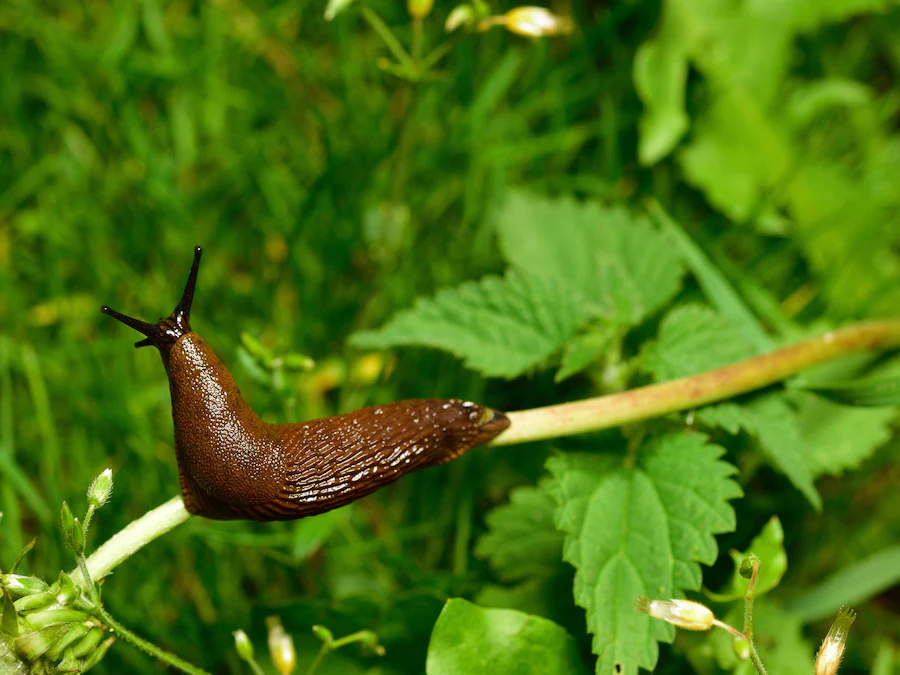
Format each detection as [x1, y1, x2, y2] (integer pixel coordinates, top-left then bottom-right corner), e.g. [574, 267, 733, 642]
[0, 0, 900, 673]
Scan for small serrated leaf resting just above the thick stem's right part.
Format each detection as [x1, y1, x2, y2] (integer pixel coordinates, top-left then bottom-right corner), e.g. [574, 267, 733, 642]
[642, 304, 754, 382]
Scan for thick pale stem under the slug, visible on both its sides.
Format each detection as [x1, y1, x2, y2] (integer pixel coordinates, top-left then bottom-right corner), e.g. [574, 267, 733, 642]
[71, 321, 900, 583]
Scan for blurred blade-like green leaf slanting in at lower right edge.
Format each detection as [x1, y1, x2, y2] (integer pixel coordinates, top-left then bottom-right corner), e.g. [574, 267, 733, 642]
[788, 546, 900, 622]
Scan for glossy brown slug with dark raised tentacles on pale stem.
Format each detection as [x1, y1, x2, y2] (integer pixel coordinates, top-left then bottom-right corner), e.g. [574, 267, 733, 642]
[101, 246, 509, 520]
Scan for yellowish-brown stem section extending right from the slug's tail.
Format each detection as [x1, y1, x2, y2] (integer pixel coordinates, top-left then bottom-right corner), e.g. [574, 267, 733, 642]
[490, 321, 900, 446]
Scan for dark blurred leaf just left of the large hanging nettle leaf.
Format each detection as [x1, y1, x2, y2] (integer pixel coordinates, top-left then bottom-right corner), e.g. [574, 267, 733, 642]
[475, 487, 563, 581]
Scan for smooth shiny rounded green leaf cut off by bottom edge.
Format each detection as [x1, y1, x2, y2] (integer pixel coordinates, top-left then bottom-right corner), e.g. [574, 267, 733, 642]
[425, 598, 587, 675]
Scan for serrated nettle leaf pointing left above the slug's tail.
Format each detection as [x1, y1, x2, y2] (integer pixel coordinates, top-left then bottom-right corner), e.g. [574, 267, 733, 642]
[350, 272, 590, 378]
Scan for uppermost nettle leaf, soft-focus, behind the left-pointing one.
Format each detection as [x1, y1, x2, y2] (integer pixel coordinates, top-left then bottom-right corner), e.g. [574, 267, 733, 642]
[497, 192, 684, 326]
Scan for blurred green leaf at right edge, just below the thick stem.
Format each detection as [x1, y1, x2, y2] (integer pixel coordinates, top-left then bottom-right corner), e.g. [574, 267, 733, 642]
[797, 394, 897, 476]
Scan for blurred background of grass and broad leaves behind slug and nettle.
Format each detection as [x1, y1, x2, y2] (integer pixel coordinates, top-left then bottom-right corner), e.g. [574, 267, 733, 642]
[0, 0, 900, 673]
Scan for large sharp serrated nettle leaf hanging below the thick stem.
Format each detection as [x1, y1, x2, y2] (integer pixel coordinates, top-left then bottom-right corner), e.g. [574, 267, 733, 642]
[548, 432, 741, 675]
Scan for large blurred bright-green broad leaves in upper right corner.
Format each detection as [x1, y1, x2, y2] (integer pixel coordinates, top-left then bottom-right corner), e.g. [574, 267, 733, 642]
[634, 0, 900, 315]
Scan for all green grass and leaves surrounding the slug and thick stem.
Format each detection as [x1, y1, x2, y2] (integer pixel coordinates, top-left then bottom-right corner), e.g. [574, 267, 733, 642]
[0, 0, 900, 675]
